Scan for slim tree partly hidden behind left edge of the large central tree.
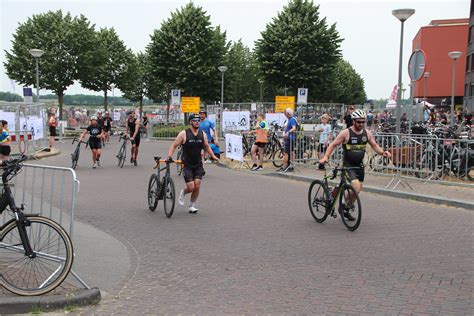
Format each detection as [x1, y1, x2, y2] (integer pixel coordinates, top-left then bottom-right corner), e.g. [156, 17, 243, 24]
[118, 53, 148, 116]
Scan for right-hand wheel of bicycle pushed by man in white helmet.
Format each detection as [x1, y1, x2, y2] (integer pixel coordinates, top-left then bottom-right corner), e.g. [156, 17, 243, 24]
[339, 184, 362, 231]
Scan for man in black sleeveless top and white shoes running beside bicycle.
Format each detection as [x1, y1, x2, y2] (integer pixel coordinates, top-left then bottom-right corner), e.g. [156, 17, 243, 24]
[168, 115, 219, 214]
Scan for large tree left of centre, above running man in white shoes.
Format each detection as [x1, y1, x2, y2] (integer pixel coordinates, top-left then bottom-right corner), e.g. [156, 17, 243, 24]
[147, 2, 227, 101]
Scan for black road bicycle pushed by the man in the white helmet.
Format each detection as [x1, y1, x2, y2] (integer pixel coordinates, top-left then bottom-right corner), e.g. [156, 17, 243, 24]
[308, 165, 362, 231]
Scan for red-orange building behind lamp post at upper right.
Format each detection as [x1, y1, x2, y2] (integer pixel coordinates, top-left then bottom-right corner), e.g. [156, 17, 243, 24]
[412, 19, 469, 105]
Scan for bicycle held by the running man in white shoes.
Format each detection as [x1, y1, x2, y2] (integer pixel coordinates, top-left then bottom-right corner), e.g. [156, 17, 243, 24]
[148, 156, 182, 218]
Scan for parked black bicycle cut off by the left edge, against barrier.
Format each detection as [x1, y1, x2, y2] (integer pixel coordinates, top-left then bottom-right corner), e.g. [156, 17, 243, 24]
[0, 156, 74, 296]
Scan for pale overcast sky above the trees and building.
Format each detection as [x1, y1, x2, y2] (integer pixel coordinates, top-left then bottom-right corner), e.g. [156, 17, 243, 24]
[0, 0, 470, 98]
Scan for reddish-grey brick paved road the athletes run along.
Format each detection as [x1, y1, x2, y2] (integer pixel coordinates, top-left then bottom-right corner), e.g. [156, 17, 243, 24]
[42, 139, 474, 315]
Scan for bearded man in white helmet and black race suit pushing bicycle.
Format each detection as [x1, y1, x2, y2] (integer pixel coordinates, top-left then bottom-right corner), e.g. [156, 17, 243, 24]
[319, 110, 391, 220]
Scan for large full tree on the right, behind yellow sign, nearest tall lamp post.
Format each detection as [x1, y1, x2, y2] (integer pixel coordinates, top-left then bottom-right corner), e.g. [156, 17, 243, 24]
[255, 0, 342, 101]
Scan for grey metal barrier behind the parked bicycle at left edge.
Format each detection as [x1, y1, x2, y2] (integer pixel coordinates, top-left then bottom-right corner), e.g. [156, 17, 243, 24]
[0, 164, 90, 289]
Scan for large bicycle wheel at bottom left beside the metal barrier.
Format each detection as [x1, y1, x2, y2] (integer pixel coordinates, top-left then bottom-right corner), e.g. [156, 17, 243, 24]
[0, 215, 74, 296]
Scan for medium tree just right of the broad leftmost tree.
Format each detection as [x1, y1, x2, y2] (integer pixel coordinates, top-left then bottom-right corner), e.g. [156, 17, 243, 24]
[80, 28, 133, 110]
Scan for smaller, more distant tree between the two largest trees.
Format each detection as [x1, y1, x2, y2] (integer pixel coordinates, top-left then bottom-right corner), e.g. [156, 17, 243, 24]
[225, 40, 260, 102]
